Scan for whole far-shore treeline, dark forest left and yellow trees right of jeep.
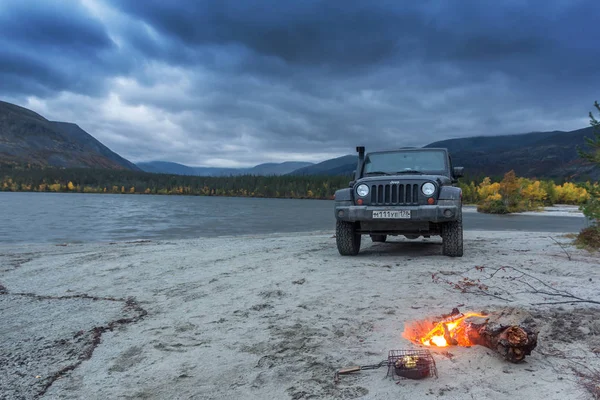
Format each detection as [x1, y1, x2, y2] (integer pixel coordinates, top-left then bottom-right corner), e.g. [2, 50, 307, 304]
[0, 166, 589, 208]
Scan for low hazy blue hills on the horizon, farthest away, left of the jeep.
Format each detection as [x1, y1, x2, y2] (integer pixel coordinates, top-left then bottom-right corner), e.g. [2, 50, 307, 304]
[137, 161, 312, 176]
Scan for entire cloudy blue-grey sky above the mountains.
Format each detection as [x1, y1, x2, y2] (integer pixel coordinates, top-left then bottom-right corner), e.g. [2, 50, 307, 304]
[0, 0, 600, 167]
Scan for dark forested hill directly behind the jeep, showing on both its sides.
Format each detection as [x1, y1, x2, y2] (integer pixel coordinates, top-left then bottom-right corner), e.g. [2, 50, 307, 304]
[284, 127, 600, 180]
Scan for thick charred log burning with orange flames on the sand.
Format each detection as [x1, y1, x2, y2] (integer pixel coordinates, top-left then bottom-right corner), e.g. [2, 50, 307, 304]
[403, 308, 538, 363]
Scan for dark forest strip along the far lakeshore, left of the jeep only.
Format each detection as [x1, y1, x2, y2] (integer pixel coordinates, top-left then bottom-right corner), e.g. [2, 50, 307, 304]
[0, 166, 349, 199]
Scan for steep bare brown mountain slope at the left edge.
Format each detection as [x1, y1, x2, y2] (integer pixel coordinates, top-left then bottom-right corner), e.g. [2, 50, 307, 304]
[0, 101, 139, 171]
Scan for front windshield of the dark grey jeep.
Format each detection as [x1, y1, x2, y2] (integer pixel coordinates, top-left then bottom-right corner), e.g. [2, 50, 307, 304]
[364, 150, 446, 175]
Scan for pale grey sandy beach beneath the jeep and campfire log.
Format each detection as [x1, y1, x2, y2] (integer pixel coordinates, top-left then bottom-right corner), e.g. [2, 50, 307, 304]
[0, 231, 600, 400]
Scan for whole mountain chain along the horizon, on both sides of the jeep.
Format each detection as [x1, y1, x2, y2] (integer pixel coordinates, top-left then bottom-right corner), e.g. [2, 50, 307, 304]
[0, 101, 600, 180]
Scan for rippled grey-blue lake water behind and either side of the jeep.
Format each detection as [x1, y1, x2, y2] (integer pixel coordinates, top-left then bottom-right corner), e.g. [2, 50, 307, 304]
[0, 192, 585, 244]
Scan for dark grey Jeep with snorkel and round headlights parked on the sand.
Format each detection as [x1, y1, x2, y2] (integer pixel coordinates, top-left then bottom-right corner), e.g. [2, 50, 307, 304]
[335, 146, 463, 257]
